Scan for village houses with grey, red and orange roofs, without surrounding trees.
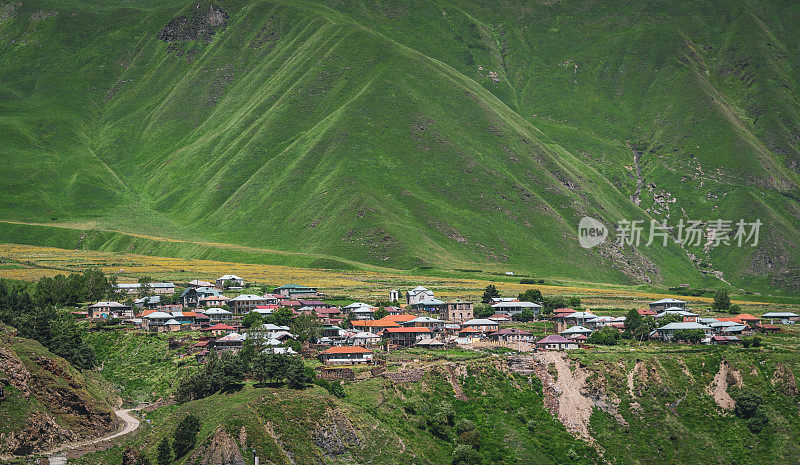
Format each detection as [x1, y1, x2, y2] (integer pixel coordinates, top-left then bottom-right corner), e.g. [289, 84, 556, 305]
[78, 275, 799, 364]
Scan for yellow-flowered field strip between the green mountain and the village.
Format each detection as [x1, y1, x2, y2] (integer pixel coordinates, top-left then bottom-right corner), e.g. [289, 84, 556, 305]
[0, 244, 798, 312]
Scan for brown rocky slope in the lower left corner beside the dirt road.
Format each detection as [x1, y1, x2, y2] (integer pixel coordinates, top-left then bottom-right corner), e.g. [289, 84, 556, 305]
[0, 325, 117, 457]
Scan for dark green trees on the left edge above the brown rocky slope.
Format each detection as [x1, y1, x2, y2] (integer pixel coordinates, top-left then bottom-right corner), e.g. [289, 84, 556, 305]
[0, 275, 97, 369]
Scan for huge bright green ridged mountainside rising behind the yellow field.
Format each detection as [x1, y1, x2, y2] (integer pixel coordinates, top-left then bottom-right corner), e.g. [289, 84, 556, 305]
[0, 0, 800, 289]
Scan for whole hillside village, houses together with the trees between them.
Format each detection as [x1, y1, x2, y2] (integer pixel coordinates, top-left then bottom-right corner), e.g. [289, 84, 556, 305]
[73, 274, 800, 366]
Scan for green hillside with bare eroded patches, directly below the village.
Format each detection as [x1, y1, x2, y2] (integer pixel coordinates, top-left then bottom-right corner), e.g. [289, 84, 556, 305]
[70, 348, 800, 464]
